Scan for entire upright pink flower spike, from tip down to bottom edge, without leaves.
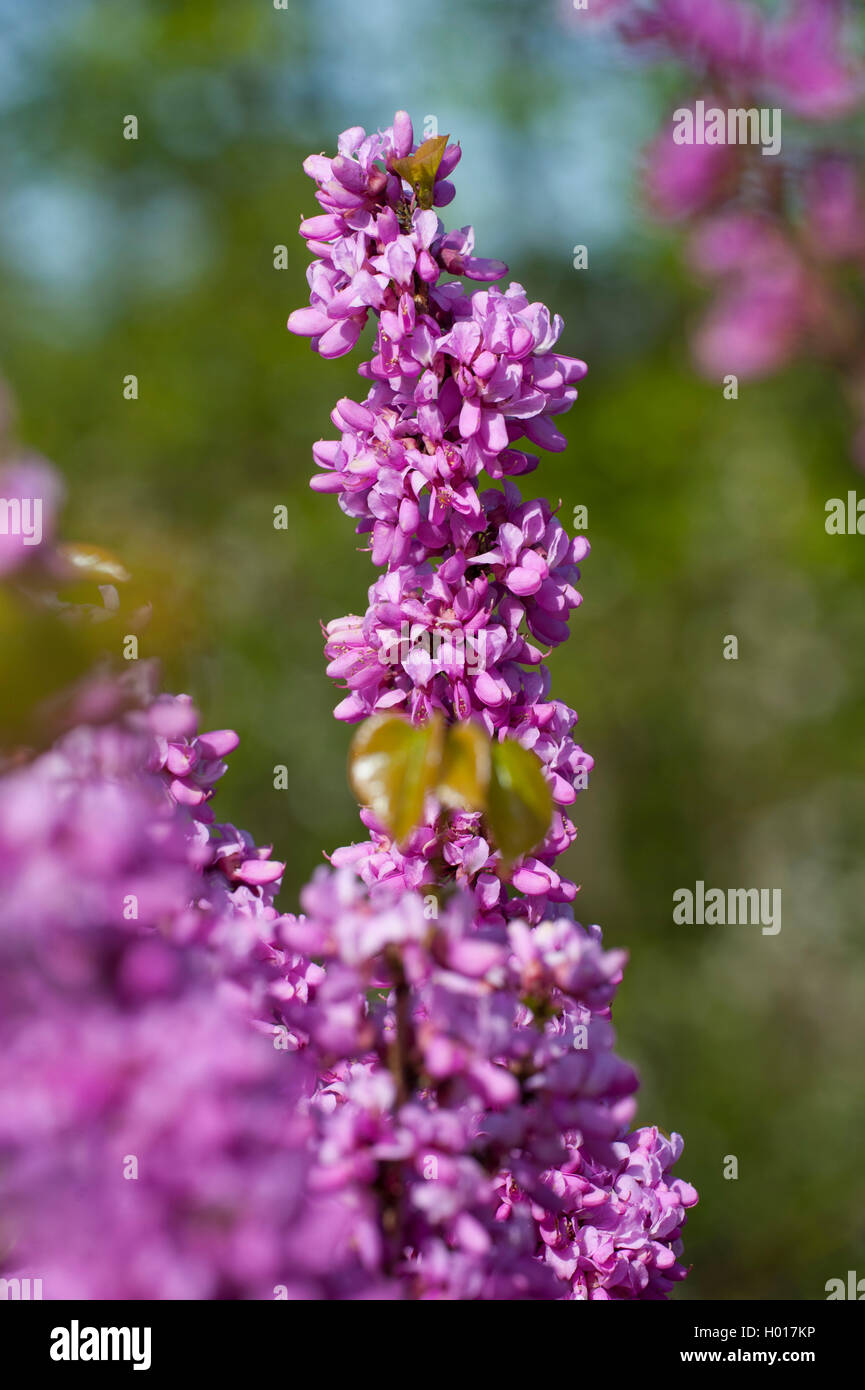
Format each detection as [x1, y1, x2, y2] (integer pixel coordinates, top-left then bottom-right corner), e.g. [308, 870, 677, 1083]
[292, 113, 697, 1298]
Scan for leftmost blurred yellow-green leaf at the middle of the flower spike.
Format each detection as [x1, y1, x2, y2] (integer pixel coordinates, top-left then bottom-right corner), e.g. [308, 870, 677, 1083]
[349, 714, 445, 845]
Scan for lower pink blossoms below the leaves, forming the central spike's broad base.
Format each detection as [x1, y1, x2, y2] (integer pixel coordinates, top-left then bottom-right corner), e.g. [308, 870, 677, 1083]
[280, 869, 697, 1298]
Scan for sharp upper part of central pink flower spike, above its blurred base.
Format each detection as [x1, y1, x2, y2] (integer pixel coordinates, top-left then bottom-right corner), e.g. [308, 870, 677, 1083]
[288, 113, 592, 920]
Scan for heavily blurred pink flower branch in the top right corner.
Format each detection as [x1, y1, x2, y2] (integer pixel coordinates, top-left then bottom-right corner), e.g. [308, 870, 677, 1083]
[595, 0, 865, 467]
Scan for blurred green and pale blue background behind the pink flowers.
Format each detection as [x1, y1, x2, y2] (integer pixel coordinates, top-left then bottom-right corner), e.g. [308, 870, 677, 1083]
[0, 0, 865, 1300]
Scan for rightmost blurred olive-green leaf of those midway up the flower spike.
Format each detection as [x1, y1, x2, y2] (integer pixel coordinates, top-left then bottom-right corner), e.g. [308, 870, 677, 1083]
[487, 738, 552, 866]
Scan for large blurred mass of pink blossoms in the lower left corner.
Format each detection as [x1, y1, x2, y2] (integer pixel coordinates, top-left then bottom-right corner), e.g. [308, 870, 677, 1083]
[0, 689, 339, 1298]
